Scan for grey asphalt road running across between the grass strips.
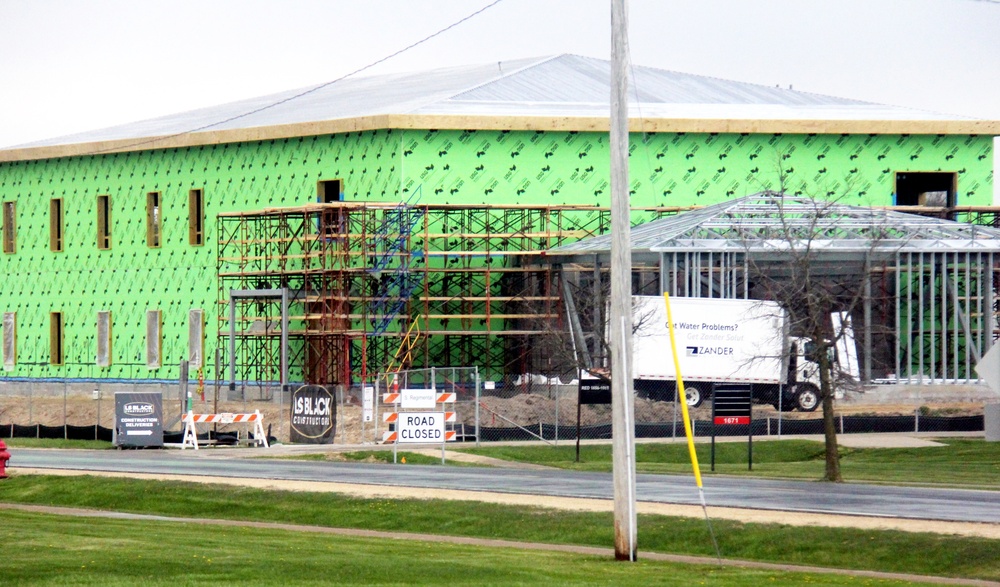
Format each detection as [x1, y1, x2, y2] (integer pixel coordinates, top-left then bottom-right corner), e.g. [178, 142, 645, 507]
[9, 449, 1000, 523]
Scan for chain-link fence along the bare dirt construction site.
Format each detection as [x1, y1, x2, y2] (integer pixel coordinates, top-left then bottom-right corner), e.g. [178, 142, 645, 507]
[0, 367, 984, 445]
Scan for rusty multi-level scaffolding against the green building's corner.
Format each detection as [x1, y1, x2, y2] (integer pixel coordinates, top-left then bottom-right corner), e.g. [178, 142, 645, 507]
[217, 202, 680, 386]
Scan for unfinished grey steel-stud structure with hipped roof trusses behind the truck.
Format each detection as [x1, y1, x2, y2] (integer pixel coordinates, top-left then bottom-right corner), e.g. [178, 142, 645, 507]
[550, 192, 1000, 383]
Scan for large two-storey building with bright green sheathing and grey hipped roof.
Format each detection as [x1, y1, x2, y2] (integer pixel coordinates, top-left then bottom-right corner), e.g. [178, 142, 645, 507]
[0, 55, 1000, 389]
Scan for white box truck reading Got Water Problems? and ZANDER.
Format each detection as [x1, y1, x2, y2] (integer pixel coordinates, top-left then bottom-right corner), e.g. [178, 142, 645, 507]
[633, 296, 836, 411]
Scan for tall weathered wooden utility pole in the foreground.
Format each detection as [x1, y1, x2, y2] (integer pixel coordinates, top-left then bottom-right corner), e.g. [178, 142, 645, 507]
[608, 0, 637, 561]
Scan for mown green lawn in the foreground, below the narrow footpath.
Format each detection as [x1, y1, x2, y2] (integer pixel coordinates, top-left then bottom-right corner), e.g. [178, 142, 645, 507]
[0, 511, 936, 587]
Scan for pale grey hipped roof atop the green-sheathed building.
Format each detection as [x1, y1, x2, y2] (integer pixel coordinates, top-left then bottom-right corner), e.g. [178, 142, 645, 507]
[9, 55, 974, 149]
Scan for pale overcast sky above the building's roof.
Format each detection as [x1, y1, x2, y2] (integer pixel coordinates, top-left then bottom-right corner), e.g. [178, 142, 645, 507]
[0, 0, 1000, 146]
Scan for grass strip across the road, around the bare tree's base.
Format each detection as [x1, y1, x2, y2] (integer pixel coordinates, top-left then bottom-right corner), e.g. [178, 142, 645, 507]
[460, 438, 1000, 490]
